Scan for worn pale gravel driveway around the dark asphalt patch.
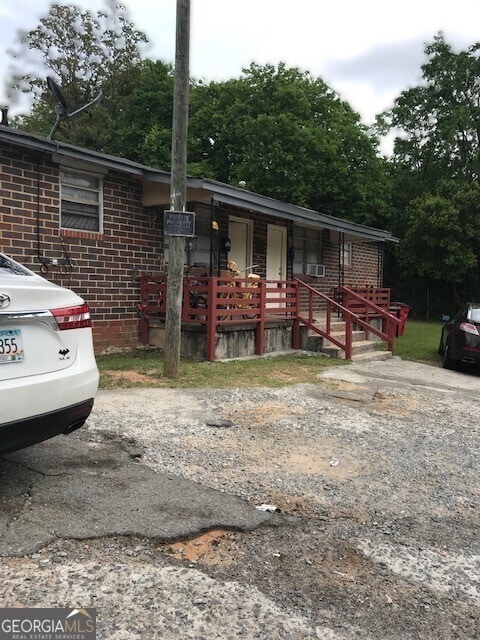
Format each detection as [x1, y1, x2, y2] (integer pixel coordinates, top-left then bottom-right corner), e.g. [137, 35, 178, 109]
[0, 359, 480, 640]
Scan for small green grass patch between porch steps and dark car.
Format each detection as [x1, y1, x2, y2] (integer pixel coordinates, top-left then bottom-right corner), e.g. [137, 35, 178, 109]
[393, 319, 442, 366]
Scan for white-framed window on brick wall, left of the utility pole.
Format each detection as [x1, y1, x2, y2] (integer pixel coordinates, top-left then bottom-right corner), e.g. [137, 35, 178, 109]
[60, 169, 103, 231]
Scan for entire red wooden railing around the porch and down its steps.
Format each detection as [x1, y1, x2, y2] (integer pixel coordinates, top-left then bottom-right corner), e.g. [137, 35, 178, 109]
[138, 275, 400, 362]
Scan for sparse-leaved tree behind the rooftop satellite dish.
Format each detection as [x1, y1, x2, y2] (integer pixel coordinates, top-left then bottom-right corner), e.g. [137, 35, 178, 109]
[9, 1, 147, 149]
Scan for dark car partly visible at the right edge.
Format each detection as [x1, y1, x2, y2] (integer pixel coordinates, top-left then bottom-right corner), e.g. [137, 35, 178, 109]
[438, 302, 480, 369]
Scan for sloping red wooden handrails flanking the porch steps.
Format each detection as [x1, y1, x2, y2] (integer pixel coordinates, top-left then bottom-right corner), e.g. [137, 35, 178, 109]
[293, 279, 400, 360]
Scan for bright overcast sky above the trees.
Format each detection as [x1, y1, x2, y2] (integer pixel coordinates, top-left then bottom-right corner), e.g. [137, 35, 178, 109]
[0, 0, 480, 130]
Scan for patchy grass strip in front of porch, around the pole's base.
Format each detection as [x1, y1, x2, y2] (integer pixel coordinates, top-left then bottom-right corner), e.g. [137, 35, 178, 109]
[97, 350, 345, 389]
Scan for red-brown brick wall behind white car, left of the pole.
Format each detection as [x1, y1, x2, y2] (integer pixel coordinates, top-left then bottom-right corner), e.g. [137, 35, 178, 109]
[0, 145, 163, 351]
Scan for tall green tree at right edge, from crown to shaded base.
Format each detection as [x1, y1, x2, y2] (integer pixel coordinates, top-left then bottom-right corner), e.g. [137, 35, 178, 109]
[377, 33, 480, 310]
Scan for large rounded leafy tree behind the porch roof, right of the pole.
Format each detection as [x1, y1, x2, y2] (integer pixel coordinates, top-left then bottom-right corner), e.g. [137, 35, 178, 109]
[189, 64, 389, 224]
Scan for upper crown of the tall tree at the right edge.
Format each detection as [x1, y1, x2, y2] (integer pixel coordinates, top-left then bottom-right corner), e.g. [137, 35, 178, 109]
[379, 33, 480, 191]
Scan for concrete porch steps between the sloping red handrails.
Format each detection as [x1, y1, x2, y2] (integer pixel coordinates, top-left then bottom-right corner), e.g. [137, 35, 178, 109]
[307, 318, 392, 362]
